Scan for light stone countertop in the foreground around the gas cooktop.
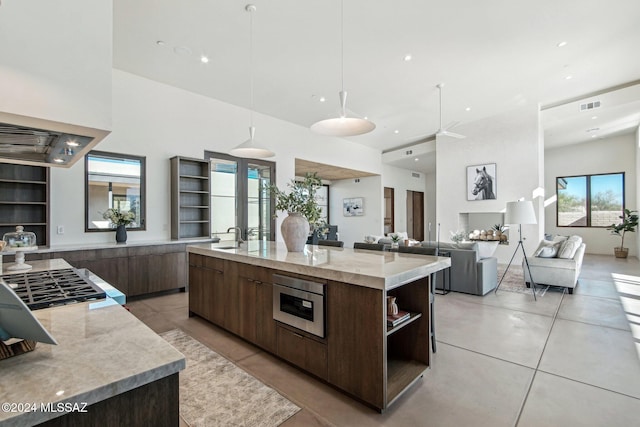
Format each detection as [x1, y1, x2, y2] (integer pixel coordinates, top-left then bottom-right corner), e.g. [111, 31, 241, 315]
[0, 272, 185, 426]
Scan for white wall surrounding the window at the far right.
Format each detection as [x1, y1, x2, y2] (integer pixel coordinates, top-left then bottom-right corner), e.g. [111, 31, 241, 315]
[544, 134, 638, 256]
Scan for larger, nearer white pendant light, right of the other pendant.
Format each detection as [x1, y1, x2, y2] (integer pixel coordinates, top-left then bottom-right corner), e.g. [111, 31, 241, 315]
[311, 0, 376, 136]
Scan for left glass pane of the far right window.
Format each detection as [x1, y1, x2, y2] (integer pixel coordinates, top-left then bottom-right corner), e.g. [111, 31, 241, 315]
[557, 176, 587, 227]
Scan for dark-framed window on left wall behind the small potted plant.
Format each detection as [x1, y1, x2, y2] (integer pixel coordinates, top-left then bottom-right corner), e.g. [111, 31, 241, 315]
[84, 151, 146, 231]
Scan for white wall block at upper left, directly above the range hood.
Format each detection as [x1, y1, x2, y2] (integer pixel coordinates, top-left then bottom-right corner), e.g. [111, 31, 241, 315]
[0, 0, 113, 129]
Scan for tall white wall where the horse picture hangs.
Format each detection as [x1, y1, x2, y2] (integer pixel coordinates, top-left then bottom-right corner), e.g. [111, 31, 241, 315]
[436, 105, 544, 264]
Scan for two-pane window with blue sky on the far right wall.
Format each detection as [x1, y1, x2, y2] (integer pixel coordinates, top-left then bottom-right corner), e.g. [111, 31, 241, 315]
[556, 172, 624, 227]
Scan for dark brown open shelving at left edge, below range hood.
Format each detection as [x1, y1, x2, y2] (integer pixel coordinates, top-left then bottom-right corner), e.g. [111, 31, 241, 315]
[0, 163, 50, 246]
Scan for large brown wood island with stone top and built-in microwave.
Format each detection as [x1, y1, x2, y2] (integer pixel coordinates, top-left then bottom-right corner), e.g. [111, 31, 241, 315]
[187, 241, 451, 411]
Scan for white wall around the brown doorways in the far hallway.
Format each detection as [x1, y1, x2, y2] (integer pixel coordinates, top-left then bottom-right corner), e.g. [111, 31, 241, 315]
[382, 165, 429, 239]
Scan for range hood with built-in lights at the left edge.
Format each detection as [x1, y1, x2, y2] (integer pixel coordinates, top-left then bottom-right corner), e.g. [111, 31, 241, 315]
[0, 112, 109, 168]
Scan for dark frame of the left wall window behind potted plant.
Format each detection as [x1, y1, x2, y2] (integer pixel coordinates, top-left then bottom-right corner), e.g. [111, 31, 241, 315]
[84, 150, 147, 233]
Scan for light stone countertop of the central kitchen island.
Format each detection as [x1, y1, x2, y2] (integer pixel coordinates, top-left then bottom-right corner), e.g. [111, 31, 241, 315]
[187, 241, 451, 290]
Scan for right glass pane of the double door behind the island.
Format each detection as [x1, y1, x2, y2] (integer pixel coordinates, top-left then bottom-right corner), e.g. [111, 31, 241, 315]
[247, 163, 272, 240]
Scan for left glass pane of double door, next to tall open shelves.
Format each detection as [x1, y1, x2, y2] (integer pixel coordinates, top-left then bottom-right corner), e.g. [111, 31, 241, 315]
[211, 159, 238, 240]
